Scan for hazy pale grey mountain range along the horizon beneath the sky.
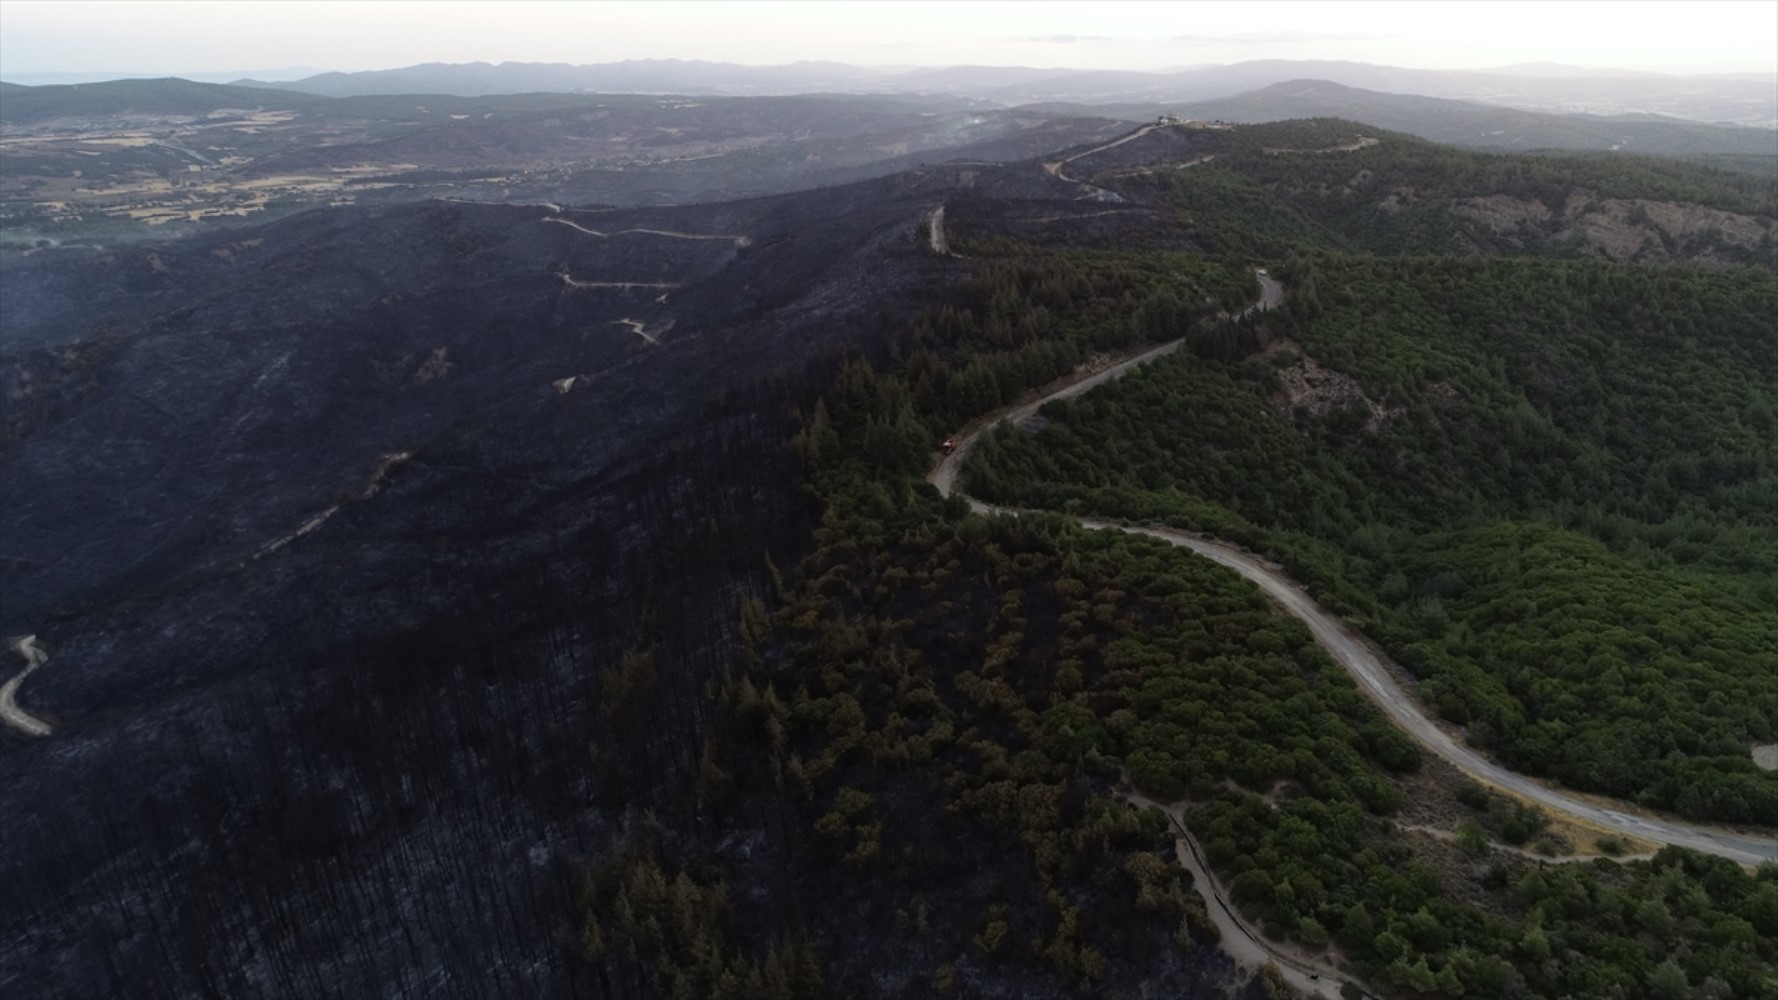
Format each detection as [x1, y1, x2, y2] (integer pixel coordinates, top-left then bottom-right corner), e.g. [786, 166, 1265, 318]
[160, 59, 1778, 128]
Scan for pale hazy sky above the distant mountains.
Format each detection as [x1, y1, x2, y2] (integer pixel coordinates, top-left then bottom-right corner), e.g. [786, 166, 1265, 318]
[0, 0, 1778, 77]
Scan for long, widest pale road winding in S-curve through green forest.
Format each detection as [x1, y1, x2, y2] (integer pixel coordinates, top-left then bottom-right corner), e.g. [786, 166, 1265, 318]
[926, 274, 1778, 865]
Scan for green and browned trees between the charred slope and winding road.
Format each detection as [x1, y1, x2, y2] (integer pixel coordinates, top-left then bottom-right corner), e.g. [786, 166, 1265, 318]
[721, 254, 1778, 996]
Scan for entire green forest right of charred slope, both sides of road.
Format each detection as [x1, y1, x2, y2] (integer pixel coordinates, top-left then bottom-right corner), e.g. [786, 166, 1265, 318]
[581, 125, 1778, 998]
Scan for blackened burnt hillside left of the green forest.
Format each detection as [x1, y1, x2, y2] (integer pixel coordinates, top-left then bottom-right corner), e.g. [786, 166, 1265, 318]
[0, 136, 1280, 996]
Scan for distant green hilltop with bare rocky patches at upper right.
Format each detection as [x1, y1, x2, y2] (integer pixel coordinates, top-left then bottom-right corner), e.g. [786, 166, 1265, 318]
[1106, 119, 1778, 267]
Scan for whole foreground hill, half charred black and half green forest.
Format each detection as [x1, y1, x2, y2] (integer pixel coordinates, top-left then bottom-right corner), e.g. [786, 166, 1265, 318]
[0, 110, 1778, 1000]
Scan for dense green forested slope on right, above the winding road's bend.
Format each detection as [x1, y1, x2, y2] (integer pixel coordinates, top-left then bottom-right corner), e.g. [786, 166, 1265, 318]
[971, 258, 1778, 826]
